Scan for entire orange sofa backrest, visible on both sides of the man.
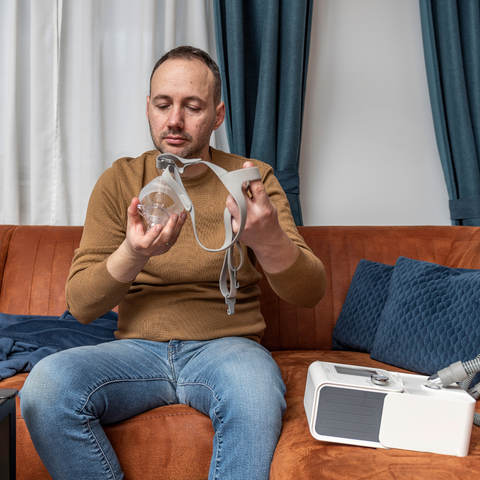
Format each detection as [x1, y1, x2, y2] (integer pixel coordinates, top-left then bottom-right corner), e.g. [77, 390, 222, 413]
[0, 225, 480, 350]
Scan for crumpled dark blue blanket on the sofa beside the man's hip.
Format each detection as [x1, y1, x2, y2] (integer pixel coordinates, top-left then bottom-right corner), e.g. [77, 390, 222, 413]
[0, 311, 118, 379]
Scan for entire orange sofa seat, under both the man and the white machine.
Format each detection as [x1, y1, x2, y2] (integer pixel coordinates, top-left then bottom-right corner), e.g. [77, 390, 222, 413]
[0, 350, 480, 480]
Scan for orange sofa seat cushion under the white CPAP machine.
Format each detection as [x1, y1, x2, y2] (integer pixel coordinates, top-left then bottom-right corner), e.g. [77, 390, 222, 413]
[270, 351, 480, 480]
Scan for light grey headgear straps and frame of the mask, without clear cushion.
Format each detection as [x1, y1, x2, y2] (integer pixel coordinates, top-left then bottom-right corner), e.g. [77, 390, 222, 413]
[156, 153, 261, 315]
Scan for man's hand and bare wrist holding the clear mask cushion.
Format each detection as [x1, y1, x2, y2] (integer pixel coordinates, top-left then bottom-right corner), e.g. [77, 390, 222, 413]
[107, 198, 187, 282]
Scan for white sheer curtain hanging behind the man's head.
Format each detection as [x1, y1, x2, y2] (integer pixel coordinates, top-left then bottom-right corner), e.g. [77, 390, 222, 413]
[0, 0, 228, 225]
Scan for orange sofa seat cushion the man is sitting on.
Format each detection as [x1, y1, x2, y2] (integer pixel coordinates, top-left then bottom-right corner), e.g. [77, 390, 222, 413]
[0, 373, 214, 480]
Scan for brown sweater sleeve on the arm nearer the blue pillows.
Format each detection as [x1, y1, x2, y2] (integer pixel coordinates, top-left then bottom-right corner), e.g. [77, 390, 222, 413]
[263, 165, 326, 308]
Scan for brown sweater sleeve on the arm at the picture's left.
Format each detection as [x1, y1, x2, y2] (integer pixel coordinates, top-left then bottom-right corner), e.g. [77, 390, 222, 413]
[65, 163, 131, 323]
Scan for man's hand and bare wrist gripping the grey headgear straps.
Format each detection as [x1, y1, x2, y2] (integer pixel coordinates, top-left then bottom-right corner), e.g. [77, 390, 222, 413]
[226, 162, 298, 273]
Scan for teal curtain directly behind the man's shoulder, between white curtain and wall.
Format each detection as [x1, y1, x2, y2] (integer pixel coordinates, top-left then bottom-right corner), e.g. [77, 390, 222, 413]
[214, 0, 313, 225]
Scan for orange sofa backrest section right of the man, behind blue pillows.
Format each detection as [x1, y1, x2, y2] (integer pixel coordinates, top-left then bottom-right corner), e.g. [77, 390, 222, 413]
[261, 226, 480, 350]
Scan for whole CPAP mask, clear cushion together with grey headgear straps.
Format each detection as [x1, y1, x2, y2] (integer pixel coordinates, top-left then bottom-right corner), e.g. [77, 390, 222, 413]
[138, 153, 261, 315]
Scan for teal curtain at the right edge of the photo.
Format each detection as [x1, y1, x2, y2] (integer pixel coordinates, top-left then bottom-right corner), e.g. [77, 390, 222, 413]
[420, 0, 480, 225]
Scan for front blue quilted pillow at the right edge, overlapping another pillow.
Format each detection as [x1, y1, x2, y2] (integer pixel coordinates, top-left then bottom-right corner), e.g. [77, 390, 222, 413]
[371, 257, 480, 375]
